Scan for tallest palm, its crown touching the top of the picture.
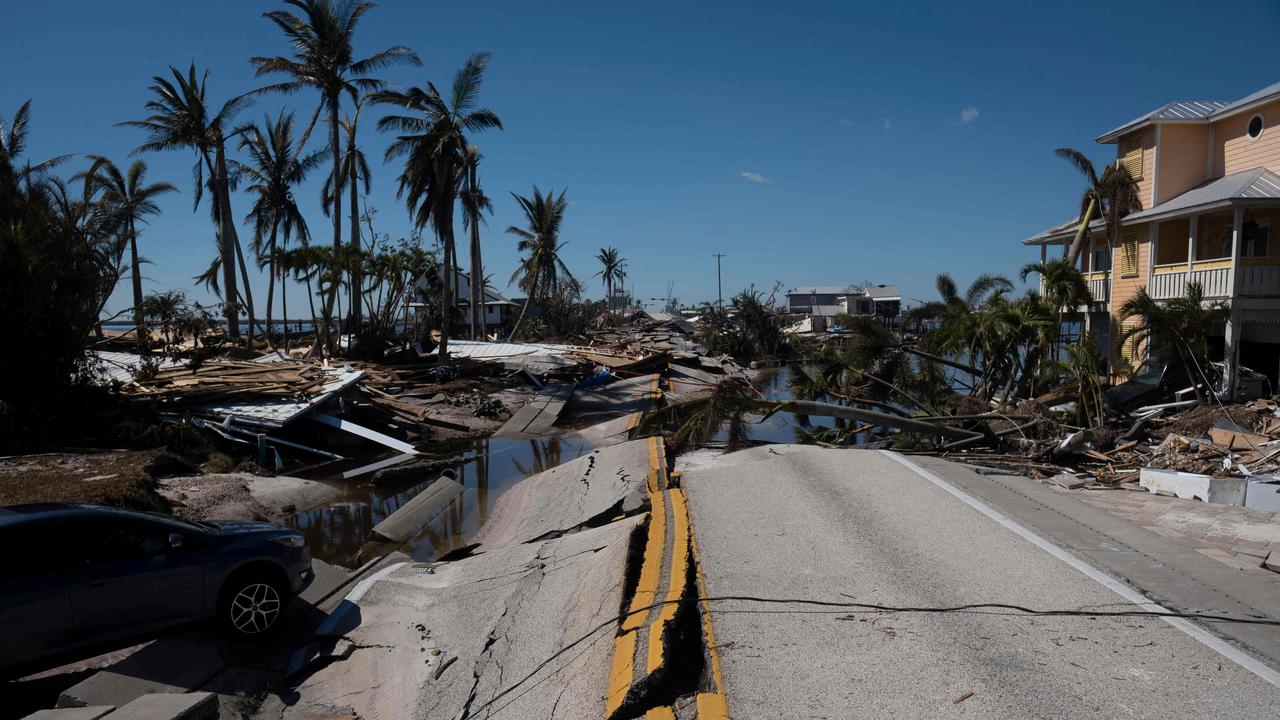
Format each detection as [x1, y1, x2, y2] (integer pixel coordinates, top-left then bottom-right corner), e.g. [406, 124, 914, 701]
[250, 0, 422, 351]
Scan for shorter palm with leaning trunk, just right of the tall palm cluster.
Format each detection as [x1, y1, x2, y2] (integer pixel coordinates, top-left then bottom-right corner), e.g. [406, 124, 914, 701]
[507, 184, 573, 337]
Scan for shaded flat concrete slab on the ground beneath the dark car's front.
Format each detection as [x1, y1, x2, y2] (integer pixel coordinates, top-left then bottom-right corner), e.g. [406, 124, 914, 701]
[58, 628, 227, 707]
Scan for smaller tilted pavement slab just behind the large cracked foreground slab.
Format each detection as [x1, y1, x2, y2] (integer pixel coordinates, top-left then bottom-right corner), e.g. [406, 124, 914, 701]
[474, 438, 659, 550]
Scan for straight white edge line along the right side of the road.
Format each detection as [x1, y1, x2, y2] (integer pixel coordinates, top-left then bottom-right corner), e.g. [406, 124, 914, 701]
[881, 450, 1280, 688]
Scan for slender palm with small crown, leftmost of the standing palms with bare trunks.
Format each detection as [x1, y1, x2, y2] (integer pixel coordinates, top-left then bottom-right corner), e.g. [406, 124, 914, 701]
[83, 155, 178, 352]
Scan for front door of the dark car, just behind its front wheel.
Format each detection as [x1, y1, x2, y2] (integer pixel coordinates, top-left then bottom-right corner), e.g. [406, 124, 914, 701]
[70, 518, 205, 637]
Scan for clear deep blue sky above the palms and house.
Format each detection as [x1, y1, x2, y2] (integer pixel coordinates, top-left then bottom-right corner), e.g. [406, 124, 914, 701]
[0, 0, 1280, 314]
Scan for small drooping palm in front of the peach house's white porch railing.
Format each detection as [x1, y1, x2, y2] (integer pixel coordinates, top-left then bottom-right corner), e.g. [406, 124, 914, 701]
[1120, 282, 1228, 402]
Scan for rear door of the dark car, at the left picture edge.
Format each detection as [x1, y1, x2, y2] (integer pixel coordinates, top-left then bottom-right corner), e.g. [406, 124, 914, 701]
[0, 525, 76, 666]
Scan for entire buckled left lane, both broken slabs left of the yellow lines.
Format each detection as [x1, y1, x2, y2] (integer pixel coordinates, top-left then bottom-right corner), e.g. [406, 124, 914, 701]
[279, 439, 696, 719]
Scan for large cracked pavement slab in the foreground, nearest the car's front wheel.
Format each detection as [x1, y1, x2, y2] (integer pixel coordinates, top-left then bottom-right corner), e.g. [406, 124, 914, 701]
[283, 518, 643, 720]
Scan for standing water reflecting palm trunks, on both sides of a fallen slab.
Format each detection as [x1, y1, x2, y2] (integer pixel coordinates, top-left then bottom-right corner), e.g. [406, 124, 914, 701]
[289, 434, 594, 566]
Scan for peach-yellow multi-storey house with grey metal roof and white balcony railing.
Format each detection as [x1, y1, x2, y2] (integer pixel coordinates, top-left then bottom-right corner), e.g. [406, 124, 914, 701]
[1023, 83, 1280, 388]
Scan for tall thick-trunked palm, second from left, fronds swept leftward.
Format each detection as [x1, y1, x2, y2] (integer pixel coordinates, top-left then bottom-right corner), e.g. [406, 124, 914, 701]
[119, 63, 253, 342]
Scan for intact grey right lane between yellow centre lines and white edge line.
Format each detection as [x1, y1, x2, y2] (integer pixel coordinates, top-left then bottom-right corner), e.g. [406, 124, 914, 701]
[677, 446, 1280, 720]
